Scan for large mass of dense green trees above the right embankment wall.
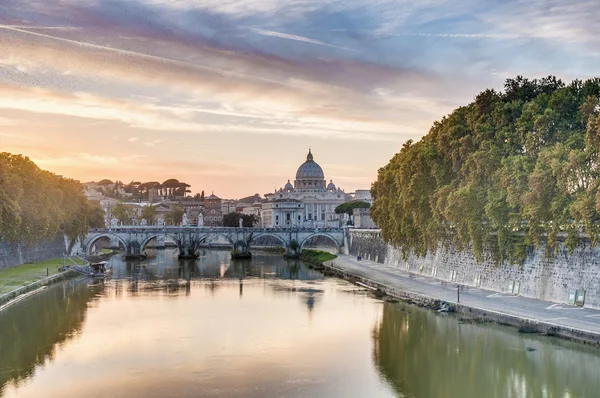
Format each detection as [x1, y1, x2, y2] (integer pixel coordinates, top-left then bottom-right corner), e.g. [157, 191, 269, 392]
[371, 76, 600, 263]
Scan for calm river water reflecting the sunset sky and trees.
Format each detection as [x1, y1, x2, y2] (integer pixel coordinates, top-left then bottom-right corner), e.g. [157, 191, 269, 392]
[0, 251, 600, 398]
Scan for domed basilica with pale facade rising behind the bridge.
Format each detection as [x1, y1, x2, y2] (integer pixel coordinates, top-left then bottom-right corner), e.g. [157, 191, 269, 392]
[262, 150, 352, 228]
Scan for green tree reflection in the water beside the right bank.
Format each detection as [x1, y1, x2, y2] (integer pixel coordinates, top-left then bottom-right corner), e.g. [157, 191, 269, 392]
[373, 303, 600, 398]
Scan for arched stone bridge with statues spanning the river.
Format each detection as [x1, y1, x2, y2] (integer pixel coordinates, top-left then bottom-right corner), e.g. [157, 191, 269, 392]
[82, 226, 348, 254]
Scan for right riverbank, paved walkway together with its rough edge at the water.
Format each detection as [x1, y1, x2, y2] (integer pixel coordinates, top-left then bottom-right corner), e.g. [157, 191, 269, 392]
[324, 255, 600, 345]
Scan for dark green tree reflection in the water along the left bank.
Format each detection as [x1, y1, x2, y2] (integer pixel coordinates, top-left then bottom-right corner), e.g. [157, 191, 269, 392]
[0, 281, 102, 396]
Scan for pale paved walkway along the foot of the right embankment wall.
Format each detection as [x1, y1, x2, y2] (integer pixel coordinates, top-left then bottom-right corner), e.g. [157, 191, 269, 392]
[331, 255, 600, 334]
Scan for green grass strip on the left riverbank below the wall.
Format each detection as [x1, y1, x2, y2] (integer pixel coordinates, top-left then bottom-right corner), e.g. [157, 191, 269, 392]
[0, 258, 83, 294]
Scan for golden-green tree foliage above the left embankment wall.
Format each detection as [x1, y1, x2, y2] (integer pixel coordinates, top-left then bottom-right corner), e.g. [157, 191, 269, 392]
[0, 153, 104, 244]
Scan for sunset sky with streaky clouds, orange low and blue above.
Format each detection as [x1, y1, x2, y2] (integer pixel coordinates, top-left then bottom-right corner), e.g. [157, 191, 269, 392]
[0, 0, 600, 198]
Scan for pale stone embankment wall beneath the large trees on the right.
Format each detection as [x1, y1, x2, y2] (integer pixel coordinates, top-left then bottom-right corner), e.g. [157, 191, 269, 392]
[350, 229, 600, 308]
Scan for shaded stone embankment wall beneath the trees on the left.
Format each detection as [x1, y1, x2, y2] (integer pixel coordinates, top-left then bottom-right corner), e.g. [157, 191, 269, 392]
[0, 234, 66, 269]
